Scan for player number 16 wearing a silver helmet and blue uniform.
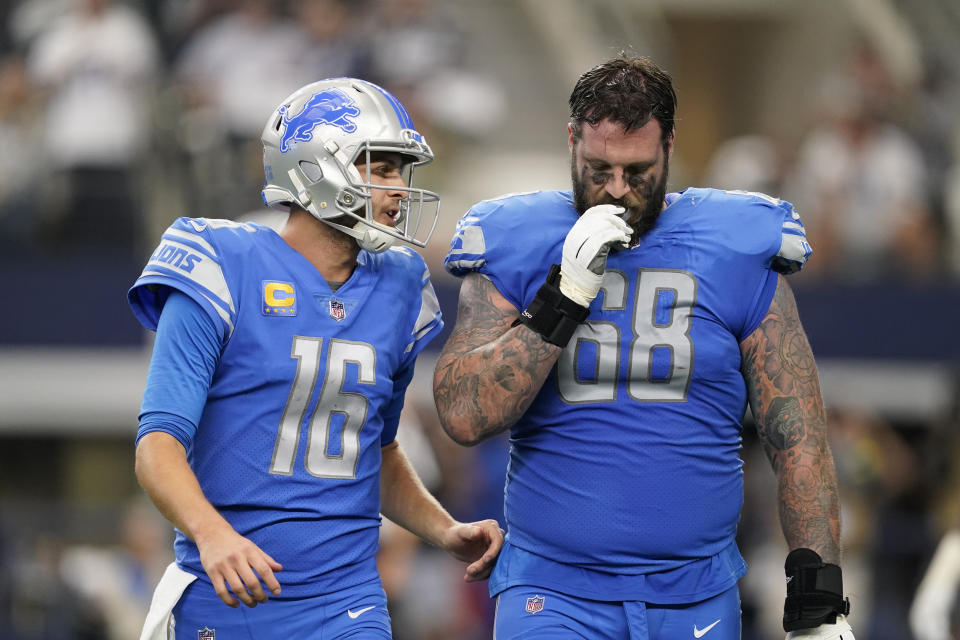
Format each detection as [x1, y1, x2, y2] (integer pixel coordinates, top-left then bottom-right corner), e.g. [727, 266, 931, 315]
[129, 78, 503, 640]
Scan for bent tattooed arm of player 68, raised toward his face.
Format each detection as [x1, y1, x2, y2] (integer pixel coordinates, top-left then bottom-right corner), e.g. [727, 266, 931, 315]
[433, 273, 563, 446]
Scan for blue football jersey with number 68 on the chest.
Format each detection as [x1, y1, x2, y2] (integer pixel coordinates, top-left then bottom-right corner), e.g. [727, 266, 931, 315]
[444, 189, 810, 603]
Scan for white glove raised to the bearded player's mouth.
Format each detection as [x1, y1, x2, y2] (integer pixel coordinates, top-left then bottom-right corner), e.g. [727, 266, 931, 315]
[560, 204, 633, 307]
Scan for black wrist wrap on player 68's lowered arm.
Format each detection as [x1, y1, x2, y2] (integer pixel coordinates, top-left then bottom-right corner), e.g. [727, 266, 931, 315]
[783, 549, 850, 631]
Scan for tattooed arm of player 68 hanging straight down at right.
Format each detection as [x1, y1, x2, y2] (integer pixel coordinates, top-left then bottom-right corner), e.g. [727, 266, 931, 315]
[740, 276, 840, 564]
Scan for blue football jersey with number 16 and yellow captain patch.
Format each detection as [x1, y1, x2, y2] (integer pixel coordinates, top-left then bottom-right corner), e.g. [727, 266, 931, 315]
[129, 218, 442, 598]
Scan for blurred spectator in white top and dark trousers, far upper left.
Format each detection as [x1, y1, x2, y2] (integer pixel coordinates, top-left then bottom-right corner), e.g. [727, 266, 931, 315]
[27, 0, 158, 260]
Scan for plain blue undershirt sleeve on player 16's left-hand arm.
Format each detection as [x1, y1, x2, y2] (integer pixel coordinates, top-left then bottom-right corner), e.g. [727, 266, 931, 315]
[137, 290, 221, 442]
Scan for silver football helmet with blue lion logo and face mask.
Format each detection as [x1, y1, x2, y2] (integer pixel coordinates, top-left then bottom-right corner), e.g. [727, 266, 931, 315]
[261, 78, 440, 252]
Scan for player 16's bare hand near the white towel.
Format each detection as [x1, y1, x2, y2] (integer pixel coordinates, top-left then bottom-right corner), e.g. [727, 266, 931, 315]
[197, 527, 283, 607]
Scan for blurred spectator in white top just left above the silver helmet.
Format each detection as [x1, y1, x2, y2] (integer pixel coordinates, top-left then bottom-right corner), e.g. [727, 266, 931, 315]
[174, 0, 306, 218]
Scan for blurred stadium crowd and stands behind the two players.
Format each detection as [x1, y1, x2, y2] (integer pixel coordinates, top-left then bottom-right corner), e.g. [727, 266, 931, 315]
[0, 0, 960, 640]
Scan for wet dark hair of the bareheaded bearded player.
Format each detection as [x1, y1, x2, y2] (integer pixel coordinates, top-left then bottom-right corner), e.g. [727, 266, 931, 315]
[570, 51, 677, 145]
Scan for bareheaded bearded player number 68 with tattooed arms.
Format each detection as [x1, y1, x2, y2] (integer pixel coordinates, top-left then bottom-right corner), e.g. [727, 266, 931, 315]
[434, 54, 853, 640]
